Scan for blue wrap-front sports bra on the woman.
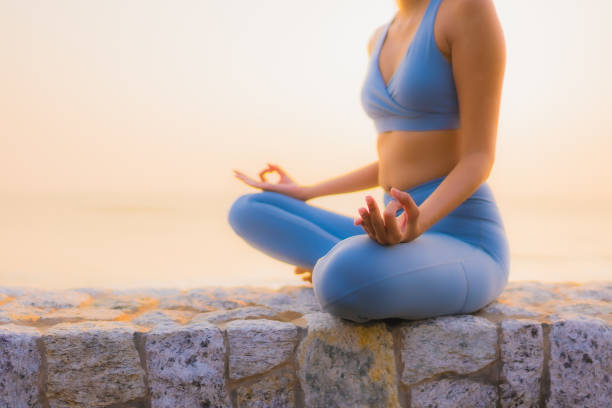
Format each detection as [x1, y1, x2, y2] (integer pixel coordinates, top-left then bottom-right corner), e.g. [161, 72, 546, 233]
[361, 0, 459, 133]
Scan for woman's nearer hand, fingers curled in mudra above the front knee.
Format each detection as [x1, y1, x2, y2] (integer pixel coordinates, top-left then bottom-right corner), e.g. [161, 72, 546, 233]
[354, 187, 424, 245]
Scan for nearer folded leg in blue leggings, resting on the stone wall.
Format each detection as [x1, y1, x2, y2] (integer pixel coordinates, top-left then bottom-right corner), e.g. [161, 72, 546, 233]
[313, 232, 506, 322]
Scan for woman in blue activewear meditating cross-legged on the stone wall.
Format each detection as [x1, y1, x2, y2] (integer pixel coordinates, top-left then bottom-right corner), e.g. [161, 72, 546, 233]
[228, 0, 510, 322]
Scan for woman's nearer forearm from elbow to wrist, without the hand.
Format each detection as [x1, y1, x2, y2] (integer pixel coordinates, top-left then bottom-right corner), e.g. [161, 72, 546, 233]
[418, 154, 492, 232]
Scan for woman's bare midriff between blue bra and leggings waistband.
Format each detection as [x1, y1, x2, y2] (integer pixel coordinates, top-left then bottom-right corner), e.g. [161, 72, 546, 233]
[376, 129, 459, 192]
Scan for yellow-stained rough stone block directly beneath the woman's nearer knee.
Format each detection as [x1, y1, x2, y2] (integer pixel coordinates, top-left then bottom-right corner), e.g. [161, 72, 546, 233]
[297, 312, 400, 408]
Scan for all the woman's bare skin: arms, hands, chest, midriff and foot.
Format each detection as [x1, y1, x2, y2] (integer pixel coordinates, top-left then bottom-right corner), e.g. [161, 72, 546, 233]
[234, 0, 506, 282]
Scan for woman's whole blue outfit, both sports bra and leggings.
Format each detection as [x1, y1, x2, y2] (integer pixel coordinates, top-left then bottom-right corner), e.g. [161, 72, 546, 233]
[228, 0, 510, 322]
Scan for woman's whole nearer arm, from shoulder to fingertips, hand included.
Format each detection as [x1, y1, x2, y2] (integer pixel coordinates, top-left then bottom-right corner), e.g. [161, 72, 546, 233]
[355, 0, 506, 245]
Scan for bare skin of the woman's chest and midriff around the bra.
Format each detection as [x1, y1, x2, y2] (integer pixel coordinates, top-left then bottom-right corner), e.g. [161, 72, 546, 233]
[368, 0, 459, 192]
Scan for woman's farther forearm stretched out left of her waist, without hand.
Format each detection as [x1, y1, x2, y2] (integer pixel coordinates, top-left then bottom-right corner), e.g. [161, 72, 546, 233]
[305, 160, 378, 200]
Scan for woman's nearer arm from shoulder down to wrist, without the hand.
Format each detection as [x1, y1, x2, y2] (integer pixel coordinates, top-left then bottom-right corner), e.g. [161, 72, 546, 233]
[419, 0, 506, 231]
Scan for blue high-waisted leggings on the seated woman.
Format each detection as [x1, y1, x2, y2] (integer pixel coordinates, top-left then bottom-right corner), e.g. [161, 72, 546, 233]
[228, 177, 510, 323]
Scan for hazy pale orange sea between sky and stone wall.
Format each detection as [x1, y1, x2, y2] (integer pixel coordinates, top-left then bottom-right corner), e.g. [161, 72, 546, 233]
[0, 189, 612, 289]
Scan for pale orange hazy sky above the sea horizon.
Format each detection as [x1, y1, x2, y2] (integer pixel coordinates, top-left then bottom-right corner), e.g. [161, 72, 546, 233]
[0, 0, 612, 199]
